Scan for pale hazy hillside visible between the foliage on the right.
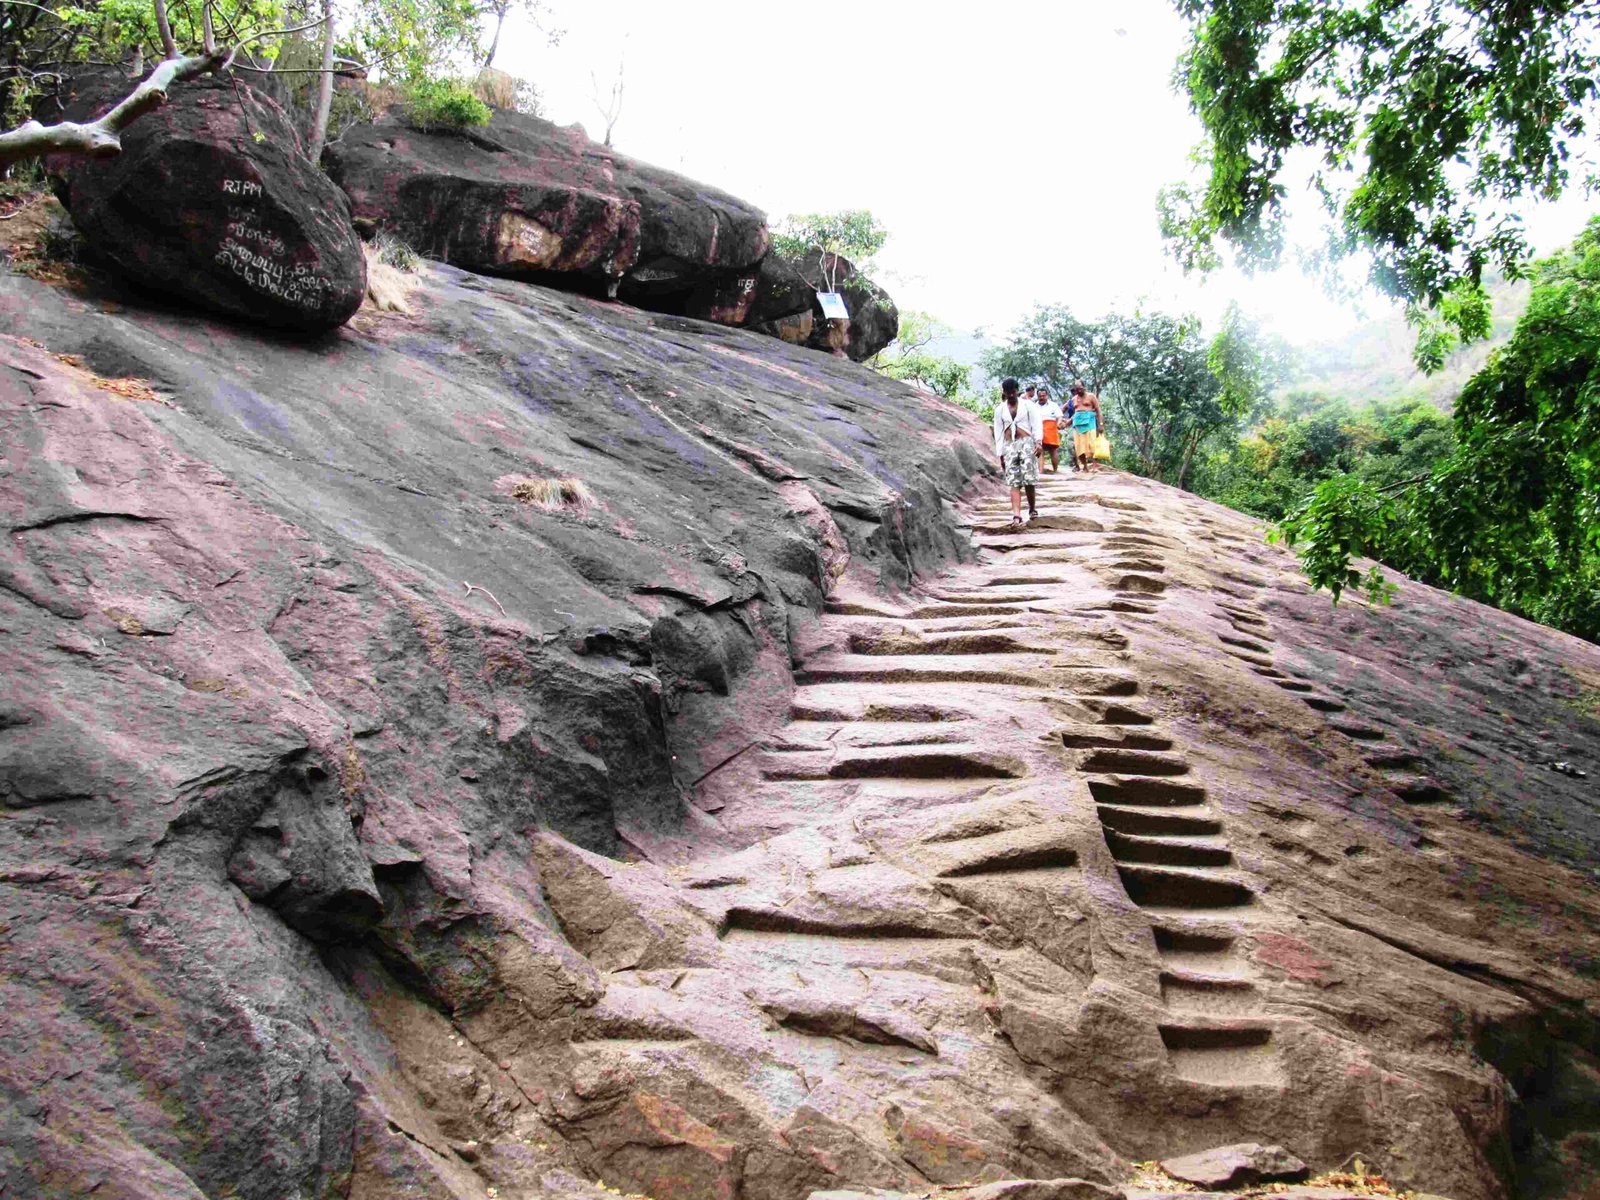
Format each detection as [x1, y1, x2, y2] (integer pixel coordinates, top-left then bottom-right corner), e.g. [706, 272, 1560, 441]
[1282, 280, 1530, 411]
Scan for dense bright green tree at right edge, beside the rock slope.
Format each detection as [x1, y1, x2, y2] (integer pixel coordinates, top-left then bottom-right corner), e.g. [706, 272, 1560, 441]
[1282, 219, 1600, 640]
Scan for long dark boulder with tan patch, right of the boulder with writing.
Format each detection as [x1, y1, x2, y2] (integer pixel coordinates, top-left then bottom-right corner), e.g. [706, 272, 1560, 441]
[326, 112, 770, 325]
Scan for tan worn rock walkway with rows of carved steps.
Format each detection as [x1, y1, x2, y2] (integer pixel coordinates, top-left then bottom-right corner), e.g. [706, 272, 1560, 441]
[556, 472, 1580, 1200]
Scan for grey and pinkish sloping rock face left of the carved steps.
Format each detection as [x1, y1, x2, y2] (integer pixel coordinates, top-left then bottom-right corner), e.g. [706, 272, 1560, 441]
[0, 267, 987, 1200]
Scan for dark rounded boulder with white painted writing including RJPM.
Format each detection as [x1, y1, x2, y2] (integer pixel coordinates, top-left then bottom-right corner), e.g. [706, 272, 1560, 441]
[46, 77, 366, 333]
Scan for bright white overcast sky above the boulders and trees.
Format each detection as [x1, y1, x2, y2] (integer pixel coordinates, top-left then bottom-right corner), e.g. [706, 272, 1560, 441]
[496, 0, 1587, 342]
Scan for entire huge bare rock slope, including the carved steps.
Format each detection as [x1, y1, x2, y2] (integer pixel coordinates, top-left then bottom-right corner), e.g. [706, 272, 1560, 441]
[0, 246, 1600, 1200]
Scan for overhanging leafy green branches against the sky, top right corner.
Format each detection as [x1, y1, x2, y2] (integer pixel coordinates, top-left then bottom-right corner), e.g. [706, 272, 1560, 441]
[1160, 0, 1600, 356]
